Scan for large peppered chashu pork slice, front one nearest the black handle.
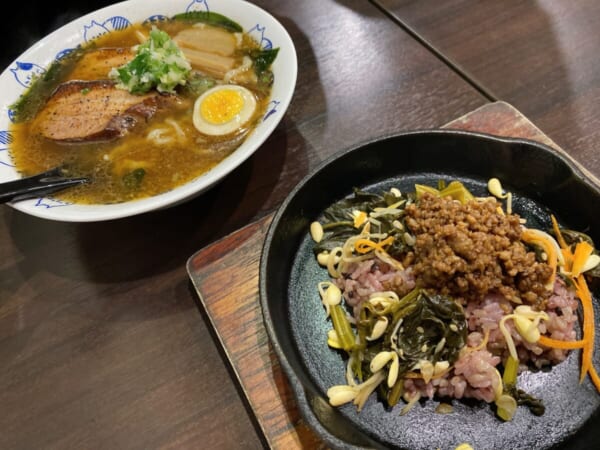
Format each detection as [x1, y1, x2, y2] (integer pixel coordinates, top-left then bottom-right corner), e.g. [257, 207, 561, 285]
[33, 80, 180, 143]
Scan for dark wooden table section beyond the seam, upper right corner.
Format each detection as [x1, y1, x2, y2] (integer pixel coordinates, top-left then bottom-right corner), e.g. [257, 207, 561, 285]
[374, 0, 600, 176]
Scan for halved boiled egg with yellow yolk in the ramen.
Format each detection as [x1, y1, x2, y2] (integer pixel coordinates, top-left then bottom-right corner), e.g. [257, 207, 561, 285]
[192, 84, 256, 136]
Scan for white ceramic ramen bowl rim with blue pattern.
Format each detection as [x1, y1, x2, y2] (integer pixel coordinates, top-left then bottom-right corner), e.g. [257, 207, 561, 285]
[0, 0, 297, 222]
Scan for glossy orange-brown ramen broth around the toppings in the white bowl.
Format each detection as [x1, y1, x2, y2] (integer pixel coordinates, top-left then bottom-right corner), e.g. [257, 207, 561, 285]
[10, 20, 269, 204]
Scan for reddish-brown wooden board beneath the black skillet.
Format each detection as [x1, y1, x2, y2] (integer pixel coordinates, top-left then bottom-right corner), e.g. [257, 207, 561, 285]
[187, 102, 572, 450]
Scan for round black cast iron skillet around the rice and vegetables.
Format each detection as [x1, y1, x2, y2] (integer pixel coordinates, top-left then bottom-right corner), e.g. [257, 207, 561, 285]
[260, 130, 600, 450]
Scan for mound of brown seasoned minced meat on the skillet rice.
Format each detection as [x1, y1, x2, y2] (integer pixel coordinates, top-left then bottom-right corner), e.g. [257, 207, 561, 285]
[406, 194, 552, 303]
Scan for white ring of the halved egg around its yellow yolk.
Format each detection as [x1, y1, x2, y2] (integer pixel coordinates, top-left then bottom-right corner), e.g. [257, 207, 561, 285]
[192, 84, 256, 136]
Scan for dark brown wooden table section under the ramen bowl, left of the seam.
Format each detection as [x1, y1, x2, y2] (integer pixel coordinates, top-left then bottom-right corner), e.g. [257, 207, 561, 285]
[0, 0, 600, 449]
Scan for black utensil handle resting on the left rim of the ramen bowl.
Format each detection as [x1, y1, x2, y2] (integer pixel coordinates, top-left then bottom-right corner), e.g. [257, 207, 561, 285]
[0, 167, 89, 203]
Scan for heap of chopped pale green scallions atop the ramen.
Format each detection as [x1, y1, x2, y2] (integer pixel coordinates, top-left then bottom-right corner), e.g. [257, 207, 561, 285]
[109, 27, 191, 94]
